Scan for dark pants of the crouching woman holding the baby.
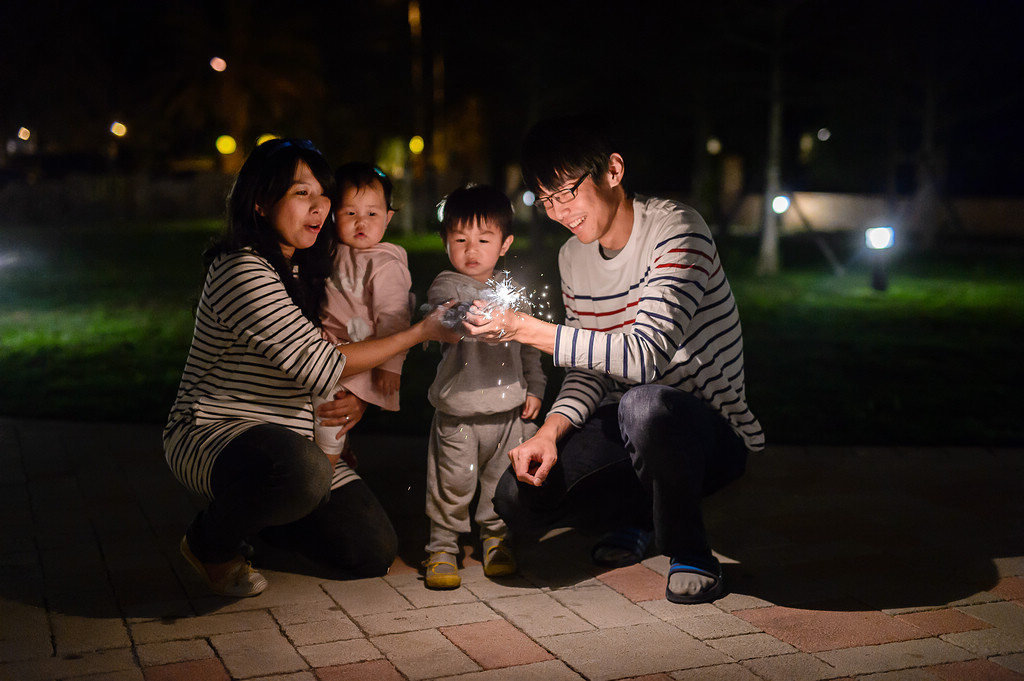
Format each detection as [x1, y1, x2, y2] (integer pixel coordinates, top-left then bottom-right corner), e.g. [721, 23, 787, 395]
[187, 424, 398, 577]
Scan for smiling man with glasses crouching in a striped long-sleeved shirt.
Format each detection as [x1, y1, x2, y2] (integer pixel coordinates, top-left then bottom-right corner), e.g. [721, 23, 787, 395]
[465, 117, 764, 603]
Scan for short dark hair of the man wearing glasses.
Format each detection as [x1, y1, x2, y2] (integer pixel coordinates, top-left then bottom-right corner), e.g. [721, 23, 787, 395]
[519, 116, 621, 194]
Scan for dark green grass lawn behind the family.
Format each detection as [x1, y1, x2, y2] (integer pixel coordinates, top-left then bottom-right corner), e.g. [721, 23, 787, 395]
[0, 221, 1024, 445]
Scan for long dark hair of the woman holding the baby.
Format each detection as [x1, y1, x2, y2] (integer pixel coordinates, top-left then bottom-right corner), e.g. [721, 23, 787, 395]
[203, 139, 337, 326]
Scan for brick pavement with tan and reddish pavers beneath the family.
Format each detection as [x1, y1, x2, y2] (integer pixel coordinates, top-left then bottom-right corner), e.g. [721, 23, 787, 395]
[0, 419, 1024, 681]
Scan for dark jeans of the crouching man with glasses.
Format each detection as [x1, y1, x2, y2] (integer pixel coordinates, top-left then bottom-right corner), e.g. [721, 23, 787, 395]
[495, 385, 746, 559]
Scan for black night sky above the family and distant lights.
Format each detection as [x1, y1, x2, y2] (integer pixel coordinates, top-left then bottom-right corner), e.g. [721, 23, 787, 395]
[0, 0, 1024, 196]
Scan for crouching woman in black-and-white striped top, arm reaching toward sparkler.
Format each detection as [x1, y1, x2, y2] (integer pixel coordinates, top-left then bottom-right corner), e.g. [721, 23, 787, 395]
[164, 139, 459, 597]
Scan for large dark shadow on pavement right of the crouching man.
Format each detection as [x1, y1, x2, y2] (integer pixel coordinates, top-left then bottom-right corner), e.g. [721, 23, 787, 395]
[706, 448, 1024, 610]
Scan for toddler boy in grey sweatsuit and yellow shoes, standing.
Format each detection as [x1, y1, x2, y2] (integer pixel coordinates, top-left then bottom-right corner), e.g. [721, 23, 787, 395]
[424, 185, 547, 589]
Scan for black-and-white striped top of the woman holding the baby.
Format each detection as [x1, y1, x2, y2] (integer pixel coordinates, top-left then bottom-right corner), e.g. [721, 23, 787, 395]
[164, 249, 356, 498]
